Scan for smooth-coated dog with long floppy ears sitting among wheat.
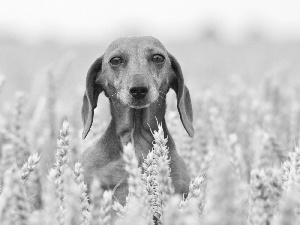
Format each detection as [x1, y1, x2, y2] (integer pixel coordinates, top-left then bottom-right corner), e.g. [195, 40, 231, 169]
[81, 37, 194, 205]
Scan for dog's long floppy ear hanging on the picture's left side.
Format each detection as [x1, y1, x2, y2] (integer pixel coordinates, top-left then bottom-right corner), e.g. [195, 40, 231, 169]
[81, 56, 103, 139]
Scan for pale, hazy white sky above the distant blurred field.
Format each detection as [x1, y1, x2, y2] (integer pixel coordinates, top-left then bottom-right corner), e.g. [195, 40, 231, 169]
[0, 0, 300, 41]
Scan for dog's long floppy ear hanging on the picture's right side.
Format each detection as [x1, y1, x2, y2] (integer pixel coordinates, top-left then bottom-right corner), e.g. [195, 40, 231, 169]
[168, 53, 194, 137]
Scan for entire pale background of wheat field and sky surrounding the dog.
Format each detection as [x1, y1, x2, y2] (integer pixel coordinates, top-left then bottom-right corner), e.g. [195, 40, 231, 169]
[0, 0, 300, 225]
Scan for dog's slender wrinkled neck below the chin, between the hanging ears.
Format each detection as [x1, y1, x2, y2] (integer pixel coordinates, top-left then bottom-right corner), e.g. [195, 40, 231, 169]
[107, 99, 172, 162]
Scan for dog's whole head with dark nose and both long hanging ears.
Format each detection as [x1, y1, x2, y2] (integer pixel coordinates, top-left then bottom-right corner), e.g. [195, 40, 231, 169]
[82, 37, 194, 138]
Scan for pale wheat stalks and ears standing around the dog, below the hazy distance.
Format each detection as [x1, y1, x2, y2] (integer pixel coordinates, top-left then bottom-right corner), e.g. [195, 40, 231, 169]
[0, 41, 300, 225]
